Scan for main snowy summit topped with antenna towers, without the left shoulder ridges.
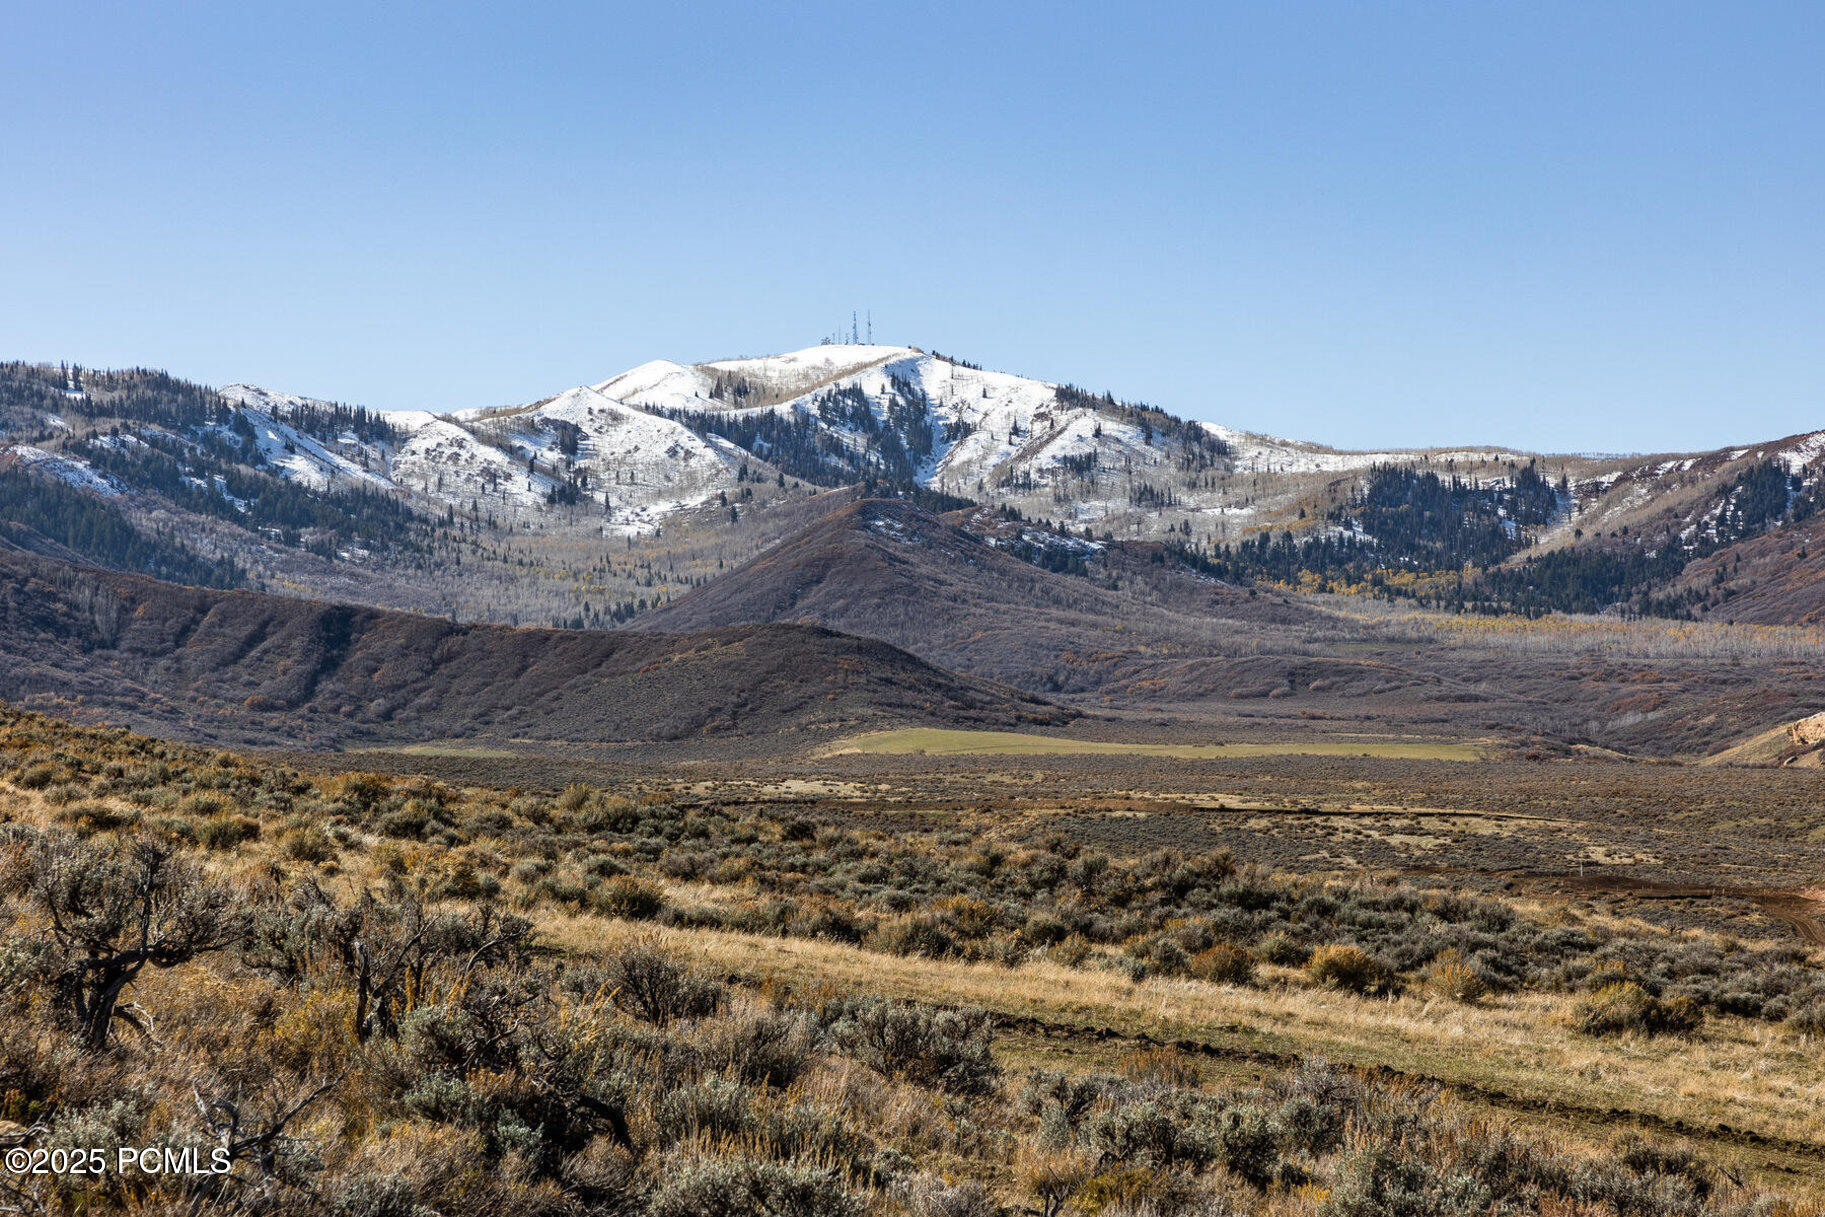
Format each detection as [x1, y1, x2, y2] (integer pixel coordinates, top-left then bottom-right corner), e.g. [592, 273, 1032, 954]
[595, 345, 1562, 538]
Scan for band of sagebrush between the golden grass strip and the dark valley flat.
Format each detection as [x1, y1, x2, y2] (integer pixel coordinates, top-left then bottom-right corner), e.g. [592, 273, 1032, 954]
[0, 708, 1825, 1027]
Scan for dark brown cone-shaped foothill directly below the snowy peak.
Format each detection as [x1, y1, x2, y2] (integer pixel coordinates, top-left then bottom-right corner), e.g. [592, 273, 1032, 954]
[633, 500, 1319, 693]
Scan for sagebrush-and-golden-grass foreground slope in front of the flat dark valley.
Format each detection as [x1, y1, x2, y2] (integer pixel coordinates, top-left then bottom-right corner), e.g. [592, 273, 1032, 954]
[0, 712, 1825, 1217]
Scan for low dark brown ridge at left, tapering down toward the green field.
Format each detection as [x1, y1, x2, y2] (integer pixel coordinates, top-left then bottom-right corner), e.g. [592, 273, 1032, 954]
[0, 553, 1066, 746]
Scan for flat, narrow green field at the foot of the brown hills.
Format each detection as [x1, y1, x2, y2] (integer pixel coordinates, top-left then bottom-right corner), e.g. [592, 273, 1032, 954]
[832, 726, 1486, 761]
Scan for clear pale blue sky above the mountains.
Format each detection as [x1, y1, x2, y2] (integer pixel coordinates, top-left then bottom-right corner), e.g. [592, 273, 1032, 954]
[0, 0, 1825, 451]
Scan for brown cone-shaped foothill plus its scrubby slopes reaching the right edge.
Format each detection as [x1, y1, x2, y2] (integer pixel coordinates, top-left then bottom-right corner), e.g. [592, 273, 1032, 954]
[646, 500, 1825, 757]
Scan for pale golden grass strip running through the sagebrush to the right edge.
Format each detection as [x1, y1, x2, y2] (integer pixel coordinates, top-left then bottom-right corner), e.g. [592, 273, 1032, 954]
[540, 916, 1825, 1146]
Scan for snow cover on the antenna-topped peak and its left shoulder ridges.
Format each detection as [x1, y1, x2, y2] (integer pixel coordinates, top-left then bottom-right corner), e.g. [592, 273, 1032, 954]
[209, 352, 1598, 536]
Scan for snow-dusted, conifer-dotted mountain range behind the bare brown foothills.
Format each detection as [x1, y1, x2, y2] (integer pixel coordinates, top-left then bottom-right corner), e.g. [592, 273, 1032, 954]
[0, 345, 1825, 627]
